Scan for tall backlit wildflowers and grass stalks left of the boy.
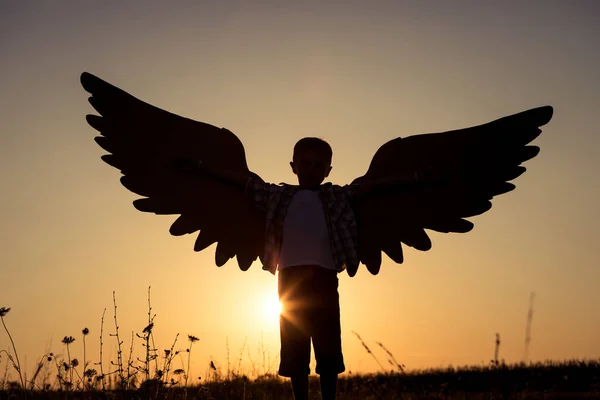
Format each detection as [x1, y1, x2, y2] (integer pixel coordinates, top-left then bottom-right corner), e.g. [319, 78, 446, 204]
[0, 287, 207, 398]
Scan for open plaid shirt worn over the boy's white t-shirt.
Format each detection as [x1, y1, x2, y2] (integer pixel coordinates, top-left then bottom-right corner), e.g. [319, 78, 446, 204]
[246, 178, 359, 274]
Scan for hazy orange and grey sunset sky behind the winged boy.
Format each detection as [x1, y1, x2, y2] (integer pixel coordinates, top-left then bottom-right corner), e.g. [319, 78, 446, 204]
[0, 0, 600, 376]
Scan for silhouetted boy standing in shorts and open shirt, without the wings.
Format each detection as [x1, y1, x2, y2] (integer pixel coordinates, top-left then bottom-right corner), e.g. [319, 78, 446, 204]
[203, 138, 358, 400]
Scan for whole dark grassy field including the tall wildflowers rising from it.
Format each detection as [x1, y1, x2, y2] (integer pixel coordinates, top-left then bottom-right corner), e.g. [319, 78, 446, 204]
[0, 296, 600, 400]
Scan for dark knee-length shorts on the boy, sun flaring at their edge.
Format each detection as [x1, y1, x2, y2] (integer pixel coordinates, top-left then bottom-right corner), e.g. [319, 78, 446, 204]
[278, 265, 345, 377]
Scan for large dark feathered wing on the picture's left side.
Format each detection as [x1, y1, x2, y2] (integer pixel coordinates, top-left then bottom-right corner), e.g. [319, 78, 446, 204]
[81, 72, 264, 270]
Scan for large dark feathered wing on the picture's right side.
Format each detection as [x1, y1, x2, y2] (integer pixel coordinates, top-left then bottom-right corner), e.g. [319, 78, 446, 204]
[348, 106, 553, 275]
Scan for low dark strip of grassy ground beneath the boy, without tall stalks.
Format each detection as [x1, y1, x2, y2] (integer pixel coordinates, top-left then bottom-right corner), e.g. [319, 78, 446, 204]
[0, 361, 600, 400]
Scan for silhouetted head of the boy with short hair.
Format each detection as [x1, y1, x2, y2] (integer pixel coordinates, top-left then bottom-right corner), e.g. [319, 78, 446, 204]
[290, 137, 333, 189]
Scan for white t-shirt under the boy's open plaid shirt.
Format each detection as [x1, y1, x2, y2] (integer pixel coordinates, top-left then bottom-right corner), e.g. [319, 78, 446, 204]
[279, 190, 335, 270]
